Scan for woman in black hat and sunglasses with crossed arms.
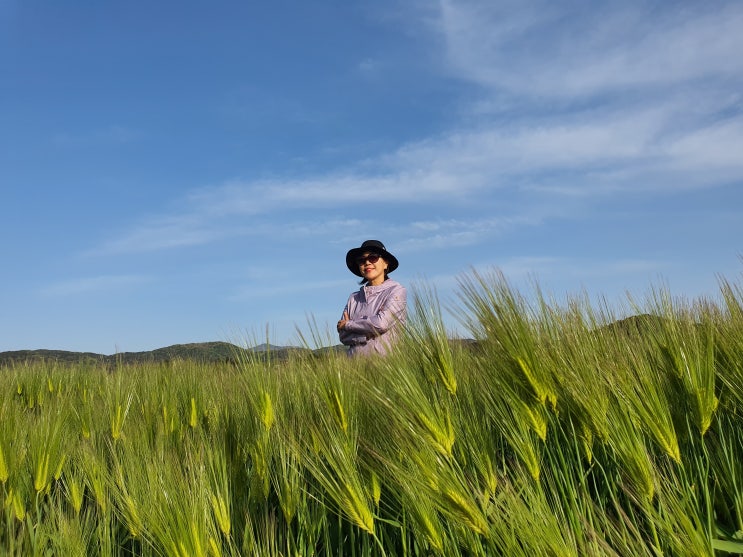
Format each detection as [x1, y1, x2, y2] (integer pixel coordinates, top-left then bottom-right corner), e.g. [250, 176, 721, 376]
[338, 240, 407, 356]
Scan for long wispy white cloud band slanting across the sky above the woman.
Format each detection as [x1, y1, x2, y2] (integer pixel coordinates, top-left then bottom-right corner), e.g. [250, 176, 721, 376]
[87, 100, 743, 254]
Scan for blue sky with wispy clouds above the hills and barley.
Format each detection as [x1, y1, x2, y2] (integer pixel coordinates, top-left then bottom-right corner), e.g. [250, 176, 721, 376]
[0, 0, 743, 354]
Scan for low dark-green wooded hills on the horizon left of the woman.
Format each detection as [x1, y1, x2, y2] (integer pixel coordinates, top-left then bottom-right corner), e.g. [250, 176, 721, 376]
[0, 342, 328, 366]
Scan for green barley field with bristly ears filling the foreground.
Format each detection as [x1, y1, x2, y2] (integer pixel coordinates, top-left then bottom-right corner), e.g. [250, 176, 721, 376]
[0, 271, 743, 557]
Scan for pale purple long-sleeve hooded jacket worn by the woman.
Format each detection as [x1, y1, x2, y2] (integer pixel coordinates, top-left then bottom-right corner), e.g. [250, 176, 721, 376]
[338, 279, 407, 356]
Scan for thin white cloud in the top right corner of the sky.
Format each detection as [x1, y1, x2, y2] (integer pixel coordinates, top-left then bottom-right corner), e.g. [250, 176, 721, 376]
[437, 0, 743, 98]
